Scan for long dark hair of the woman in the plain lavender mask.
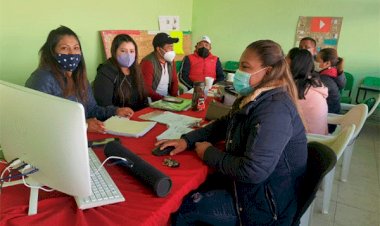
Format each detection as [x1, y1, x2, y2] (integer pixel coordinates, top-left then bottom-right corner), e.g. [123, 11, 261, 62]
[110, 34, 146, 105]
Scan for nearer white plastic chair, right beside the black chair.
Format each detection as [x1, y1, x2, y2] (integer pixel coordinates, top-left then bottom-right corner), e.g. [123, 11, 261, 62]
[307, 124, 356, 214]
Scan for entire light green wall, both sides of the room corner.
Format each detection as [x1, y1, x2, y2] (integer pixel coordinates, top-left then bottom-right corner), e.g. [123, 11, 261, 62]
[0, 0, 380, 99]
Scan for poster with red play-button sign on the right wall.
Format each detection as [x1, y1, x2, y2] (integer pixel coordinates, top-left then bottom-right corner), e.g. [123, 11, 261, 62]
[295, 16, 343, 51]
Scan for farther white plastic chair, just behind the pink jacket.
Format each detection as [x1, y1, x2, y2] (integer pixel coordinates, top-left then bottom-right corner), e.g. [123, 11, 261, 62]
[327, 104, 368, 182]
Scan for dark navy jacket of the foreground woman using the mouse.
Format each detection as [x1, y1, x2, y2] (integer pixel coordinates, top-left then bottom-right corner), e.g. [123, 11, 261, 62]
[183, 88, 307, 225]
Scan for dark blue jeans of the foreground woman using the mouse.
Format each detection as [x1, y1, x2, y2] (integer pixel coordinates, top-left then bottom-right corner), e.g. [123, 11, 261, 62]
[172, 189, 239, 226]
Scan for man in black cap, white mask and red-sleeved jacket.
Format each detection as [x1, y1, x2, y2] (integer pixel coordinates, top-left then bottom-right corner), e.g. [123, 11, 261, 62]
[141, 33, 178, 101]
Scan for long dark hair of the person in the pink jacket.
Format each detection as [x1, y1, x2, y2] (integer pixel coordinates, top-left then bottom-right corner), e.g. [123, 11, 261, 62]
[290, 49, 322, 99]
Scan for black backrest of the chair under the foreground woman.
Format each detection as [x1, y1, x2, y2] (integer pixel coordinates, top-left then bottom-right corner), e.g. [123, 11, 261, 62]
[293, 142, 337, 225]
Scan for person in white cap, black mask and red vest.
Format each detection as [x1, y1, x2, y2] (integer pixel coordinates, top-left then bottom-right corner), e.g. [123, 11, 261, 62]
[179, 36, 224, 89]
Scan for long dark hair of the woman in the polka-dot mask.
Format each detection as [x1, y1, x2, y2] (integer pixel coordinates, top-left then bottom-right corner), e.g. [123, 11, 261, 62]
[38, 26, 88, 102]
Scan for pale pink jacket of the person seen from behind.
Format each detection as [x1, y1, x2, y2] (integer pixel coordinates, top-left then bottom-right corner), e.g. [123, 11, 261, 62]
[298, 86, 328, 135]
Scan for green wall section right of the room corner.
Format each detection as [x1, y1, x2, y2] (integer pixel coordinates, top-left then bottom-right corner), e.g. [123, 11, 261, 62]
[192, 0, 380, 95]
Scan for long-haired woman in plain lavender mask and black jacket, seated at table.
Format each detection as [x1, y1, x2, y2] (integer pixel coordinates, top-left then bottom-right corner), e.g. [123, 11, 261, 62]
[93, 34, 148, 112]
